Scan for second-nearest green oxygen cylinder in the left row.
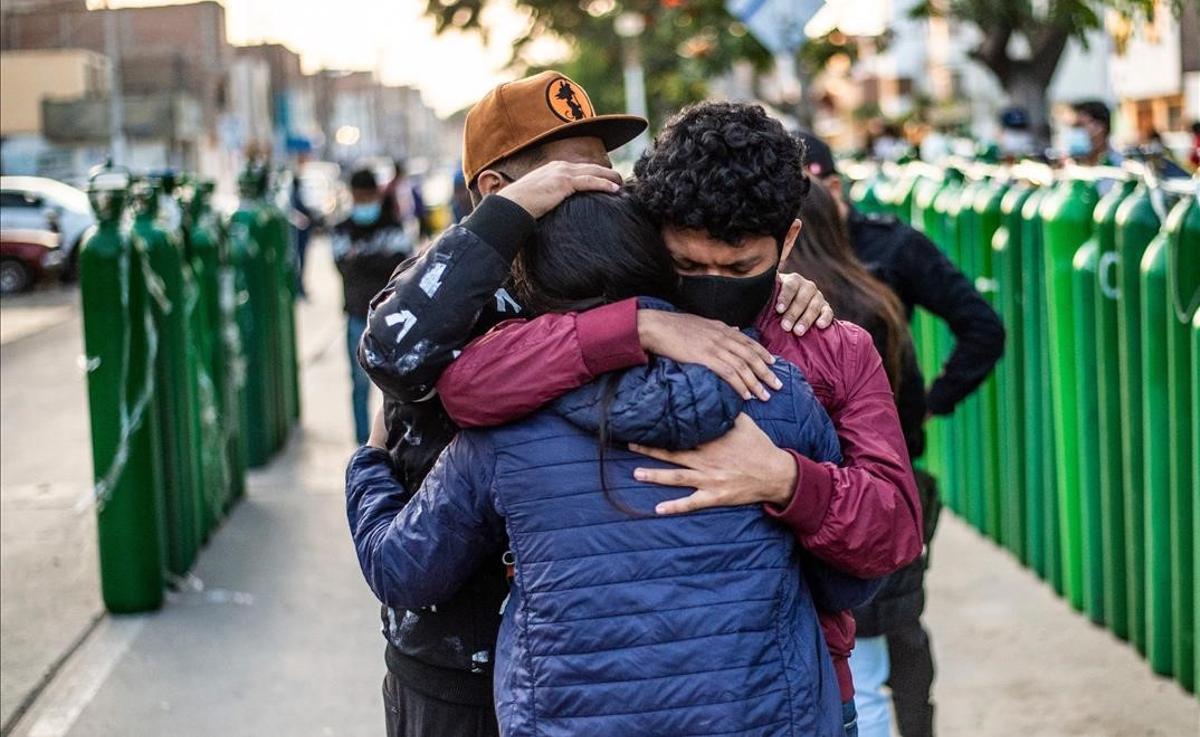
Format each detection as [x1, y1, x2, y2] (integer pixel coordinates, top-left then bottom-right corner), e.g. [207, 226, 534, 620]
[133, 178, 204, 576]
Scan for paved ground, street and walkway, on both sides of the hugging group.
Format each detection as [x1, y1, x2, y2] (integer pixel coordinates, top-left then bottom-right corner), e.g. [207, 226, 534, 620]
[0, 242, 1200, 737]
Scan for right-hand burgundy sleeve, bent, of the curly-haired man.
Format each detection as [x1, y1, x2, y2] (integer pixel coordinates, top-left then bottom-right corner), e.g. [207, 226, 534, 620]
[767, 329, 923, 579]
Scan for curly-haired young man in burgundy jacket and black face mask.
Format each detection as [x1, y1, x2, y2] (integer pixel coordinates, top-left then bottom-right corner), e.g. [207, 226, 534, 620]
[438, 102, 922, 735]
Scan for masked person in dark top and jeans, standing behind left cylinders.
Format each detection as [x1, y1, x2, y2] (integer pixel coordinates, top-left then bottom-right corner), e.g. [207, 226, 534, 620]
[332, 169, 413, 444]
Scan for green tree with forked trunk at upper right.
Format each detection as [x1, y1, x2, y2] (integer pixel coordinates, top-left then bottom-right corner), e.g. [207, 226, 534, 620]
[913, 0, 1196, 141]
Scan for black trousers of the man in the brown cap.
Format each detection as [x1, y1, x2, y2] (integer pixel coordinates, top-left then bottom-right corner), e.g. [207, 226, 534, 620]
[383, 673, 500, 737]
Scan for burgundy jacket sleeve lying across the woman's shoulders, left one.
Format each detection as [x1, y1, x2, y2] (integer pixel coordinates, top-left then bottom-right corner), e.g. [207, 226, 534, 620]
[438, 299, 646, 427]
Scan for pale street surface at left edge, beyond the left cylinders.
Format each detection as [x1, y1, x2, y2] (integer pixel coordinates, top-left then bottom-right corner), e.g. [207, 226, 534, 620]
[0, 289, 101, 724]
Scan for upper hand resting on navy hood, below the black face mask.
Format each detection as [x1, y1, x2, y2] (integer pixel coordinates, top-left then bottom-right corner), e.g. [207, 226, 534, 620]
[637, 310, 782, 401]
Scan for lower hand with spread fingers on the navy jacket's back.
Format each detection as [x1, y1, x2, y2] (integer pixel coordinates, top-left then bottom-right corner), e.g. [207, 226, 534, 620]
[629, 413, 797, 515]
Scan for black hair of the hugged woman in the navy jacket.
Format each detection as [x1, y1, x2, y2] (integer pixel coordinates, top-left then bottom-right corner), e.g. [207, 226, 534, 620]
[512, 192, 679, 516]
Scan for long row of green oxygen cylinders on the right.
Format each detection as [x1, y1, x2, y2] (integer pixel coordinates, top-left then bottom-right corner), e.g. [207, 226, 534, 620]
[851, 162, 1200, 693]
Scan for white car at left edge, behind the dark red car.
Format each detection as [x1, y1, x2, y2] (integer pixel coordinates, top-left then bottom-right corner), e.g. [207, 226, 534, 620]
[0, 176, 96, 278]
